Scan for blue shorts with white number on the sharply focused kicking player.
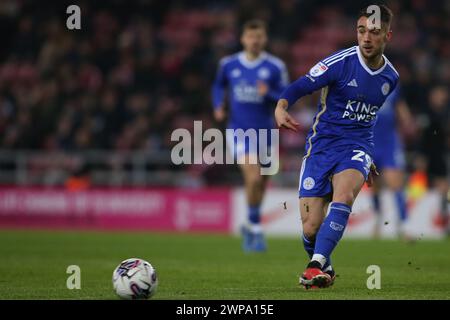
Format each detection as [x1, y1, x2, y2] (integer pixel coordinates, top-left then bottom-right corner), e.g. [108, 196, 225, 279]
[298, 146, 372, 197]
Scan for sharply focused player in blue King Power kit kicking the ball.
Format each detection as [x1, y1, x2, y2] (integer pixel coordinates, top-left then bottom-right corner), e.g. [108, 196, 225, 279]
[275, 6, 399, 288]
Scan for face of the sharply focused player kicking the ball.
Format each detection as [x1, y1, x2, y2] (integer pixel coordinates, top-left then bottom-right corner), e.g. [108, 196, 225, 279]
[357, 17, 392, 60]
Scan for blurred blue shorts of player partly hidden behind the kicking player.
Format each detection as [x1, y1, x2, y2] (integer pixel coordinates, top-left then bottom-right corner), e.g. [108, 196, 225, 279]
[373, 136, 405, 171]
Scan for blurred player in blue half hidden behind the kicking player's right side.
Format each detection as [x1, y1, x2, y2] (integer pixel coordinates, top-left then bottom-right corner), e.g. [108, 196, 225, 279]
[372, 86, 414, 237]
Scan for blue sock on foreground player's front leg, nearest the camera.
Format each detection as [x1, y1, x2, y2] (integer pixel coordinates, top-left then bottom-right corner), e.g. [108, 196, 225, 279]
[314, 202, 352, 266]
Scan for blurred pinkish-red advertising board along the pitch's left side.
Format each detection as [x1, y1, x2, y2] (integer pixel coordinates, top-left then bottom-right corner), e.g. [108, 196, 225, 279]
[0, 188, 231, 232]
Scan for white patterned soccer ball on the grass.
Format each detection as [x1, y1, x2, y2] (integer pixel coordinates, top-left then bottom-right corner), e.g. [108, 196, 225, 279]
[113, 258, 158, 300]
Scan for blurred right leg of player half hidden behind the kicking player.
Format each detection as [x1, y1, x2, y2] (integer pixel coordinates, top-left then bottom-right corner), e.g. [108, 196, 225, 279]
[382, 168, 408, 236]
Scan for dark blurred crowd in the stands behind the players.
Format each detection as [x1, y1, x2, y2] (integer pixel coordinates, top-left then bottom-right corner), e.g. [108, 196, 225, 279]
[0, 0, 450, 188]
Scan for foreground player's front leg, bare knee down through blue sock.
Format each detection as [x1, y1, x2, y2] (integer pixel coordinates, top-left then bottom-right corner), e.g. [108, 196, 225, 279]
[312, 169, 365, 267]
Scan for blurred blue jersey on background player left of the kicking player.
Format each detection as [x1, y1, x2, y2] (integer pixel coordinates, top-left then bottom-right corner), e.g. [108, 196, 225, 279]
[212, 52, 289, 130]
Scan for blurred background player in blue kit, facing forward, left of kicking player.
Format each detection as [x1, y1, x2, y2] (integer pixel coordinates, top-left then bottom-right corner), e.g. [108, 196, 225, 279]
[212, 20, 289, 252]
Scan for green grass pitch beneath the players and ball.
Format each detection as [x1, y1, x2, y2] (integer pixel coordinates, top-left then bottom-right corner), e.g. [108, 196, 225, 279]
[0, 230, 450, 300]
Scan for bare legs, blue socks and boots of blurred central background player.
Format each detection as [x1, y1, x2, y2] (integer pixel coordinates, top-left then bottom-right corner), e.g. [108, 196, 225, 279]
[239, 154, 268, 251]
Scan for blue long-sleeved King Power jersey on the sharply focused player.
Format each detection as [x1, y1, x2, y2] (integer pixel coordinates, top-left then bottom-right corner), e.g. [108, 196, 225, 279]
[281, 46, 399, 157]
